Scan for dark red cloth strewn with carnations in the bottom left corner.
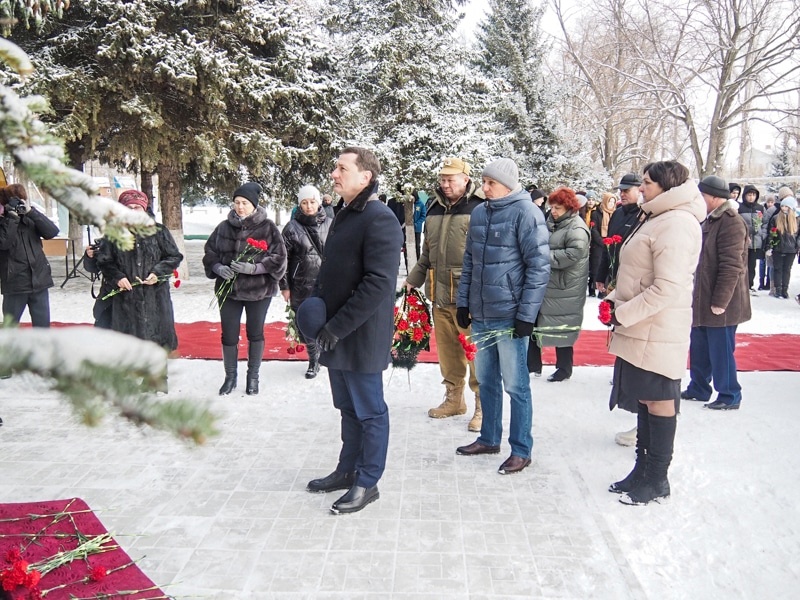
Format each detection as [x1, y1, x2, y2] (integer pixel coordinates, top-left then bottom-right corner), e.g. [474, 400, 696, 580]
[0, 498, 166, 600]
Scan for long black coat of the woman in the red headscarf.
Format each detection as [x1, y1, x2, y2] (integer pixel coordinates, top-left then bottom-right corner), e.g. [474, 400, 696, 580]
[95, 224, 183, 350]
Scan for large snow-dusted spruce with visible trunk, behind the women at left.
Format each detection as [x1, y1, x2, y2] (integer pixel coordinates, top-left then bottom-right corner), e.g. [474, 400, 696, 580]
[6, 0, 337, 240]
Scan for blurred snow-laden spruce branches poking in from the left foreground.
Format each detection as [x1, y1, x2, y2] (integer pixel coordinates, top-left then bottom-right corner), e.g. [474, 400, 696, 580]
[0, 38, 215, 443]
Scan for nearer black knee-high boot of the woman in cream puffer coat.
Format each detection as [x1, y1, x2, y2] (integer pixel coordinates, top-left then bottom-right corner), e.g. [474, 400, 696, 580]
[619, 415, 678, 505]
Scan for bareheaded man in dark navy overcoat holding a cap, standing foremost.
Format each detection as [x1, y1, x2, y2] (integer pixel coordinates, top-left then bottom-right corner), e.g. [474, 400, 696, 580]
[308, 147, 403, 514]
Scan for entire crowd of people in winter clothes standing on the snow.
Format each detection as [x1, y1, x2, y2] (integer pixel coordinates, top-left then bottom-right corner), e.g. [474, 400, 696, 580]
[0, 146, 800, 514]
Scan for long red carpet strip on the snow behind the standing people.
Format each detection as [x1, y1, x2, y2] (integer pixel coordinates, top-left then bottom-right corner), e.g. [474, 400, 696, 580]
[39, 321, 800, 371]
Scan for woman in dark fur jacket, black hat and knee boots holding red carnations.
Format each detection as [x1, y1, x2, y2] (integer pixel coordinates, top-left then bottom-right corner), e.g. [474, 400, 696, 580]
[203, 182, 286, 396]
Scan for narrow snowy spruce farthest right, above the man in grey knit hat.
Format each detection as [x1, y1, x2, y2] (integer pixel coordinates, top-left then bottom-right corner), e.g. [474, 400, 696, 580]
[474, 0, 559, 185]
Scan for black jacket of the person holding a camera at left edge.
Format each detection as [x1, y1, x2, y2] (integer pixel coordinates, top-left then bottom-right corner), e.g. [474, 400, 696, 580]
[0, 208, 58, 295]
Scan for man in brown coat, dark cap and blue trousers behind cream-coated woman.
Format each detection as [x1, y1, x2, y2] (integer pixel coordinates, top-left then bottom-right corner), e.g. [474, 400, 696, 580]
[681, 175, 750, 410]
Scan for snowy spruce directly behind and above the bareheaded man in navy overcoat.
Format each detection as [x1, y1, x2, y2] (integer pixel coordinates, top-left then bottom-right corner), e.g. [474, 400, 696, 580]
[327, 0, 486, 188]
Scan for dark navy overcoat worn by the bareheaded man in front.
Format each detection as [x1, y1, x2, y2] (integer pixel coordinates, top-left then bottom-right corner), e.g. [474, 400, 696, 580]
[313, 186, 403, 373]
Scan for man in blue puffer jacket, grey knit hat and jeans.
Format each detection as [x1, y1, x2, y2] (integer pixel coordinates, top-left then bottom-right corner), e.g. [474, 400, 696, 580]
[456, 158, 550, 475]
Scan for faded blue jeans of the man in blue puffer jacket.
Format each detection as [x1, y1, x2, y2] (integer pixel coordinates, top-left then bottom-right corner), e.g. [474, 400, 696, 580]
[472, 320, 533, 458]
